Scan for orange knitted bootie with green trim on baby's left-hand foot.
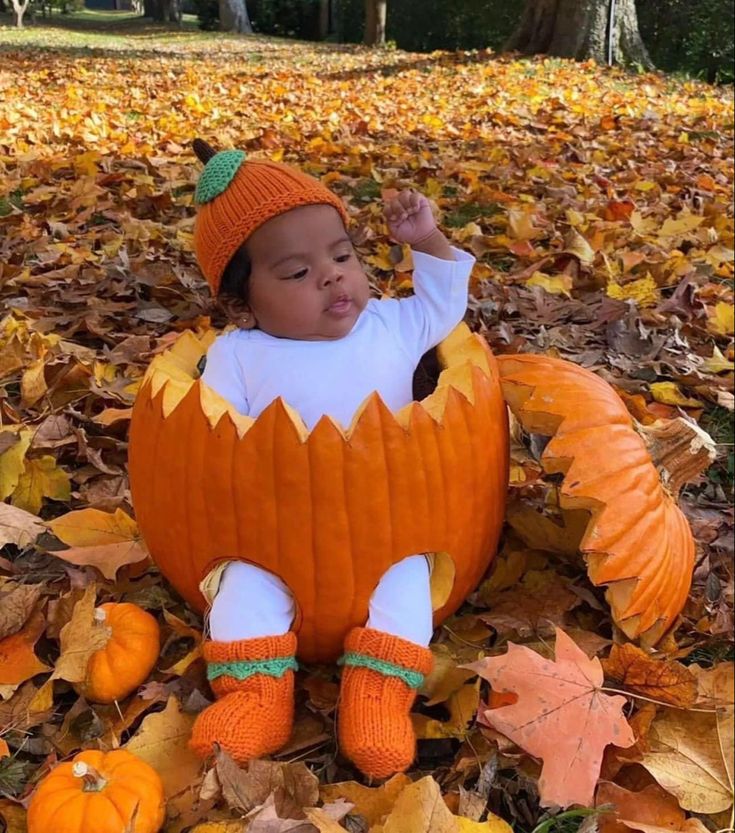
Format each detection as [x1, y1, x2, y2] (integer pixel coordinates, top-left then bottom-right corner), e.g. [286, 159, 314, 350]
[189, 632, 297, 763]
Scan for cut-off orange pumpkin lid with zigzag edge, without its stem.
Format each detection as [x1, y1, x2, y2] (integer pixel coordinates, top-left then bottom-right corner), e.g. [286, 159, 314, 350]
[498, 355, 694, 644]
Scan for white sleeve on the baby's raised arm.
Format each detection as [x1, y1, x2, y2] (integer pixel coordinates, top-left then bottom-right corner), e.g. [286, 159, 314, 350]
[397, 246, 475, 362]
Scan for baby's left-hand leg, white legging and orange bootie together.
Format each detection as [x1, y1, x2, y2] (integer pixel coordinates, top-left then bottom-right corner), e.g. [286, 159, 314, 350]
[190, 561, 296, 761]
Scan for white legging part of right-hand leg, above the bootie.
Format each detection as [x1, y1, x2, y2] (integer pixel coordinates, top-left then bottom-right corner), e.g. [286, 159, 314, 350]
[367, 555, 433, 646]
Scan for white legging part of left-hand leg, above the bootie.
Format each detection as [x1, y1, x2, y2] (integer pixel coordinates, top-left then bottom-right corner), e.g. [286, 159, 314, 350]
[209, 561, 295, 642]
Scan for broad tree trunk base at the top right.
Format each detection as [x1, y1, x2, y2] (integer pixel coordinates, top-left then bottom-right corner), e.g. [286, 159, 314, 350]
[505, 0, 653, 69]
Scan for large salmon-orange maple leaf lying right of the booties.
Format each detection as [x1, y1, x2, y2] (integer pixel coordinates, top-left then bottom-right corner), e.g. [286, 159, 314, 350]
[466, 628, 635, 807]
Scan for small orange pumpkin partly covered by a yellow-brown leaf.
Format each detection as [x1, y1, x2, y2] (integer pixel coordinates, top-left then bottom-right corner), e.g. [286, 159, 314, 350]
[75, 602, 160, 703]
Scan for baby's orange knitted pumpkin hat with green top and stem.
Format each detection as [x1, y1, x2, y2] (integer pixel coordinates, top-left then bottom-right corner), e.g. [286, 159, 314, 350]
[192, 139, 348, 295]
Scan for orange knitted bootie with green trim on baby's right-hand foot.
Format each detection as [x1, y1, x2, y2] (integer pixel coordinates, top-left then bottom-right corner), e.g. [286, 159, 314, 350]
[339, 628, 434, 778]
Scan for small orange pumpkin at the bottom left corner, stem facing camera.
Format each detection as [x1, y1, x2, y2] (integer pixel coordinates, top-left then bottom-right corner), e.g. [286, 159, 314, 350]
[28, 749, 166, 833]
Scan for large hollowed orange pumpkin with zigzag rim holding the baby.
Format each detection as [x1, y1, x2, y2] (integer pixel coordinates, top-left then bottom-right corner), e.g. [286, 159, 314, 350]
[130, 325, 508, 661]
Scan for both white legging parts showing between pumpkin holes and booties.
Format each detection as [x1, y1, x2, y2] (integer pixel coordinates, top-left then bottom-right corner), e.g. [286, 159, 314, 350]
[209, 555, 432, 646]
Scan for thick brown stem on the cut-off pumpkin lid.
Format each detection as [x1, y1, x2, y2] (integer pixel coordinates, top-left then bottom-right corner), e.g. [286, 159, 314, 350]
[636, 417, 717, 499]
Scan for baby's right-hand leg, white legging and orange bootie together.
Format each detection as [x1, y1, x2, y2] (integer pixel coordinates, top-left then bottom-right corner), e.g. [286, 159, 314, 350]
[339, 555, 434, 778]
